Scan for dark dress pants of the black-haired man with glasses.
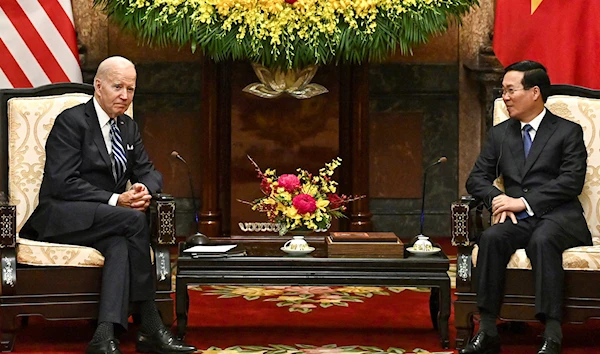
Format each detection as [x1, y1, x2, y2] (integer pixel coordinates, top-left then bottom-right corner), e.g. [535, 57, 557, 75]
[476, 216, 582, 321]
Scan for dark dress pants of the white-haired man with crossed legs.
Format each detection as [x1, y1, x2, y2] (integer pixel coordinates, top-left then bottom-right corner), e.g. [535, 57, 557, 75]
[48, 204, 155, 328]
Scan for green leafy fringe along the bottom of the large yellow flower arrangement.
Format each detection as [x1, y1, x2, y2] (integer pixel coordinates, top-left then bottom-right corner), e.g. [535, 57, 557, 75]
[94, 0, 478, 68]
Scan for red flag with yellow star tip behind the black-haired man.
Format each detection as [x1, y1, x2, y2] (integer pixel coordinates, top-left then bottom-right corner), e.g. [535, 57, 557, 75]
[494, 0, 600, 89]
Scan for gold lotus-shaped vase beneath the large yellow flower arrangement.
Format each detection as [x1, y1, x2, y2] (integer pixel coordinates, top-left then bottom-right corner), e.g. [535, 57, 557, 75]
[242, 63, 329, 99]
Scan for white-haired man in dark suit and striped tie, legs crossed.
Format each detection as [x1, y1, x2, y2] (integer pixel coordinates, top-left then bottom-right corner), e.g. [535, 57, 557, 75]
[22, 57, 195, 353]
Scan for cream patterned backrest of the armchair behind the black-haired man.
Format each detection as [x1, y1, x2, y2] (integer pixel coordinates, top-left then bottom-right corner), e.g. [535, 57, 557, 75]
[493, 85, 600, 238]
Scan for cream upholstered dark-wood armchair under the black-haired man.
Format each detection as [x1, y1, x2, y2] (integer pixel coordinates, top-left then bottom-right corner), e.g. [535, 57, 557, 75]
[451, 85, 600, 348]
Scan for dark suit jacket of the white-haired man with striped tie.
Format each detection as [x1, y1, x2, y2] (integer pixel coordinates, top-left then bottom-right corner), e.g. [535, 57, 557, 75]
[22, 100, 162, 240]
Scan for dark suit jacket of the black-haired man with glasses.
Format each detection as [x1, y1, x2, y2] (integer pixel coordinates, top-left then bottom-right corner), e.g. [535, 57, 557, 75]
[467, 110, 592, 245]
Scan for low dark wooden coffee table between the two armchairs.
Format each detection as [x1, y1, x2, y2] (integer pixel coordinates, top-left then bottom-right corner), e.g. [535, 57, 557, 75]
[176, 242, 450, 348]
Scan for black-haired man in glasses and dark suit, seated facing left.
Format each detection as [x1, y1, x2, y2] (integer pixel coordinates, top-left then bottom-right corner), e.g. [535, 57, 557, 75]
[460, 61, 592, 354]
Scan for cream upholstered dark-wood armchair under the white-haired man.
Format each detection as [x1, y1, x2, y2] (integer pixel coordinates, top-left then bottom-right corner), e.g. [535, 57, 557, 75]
[0, 83, 175, 351]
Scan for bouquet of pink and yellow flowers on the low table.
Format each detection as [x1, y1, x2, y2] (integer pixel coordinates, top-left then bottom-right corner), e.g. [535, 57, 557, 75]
[239, 156, 365, 236]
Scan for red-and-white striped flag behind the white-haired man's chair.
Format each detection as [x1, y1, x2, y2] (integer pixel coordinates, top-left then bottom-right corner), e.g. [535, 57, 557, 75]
[0, 0, 82, 89]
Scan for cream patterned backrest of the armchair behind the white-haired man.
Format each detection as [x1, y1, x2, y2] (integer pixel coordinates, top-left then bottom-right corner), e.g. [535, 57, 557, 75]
[0, 83, 133, 232]
